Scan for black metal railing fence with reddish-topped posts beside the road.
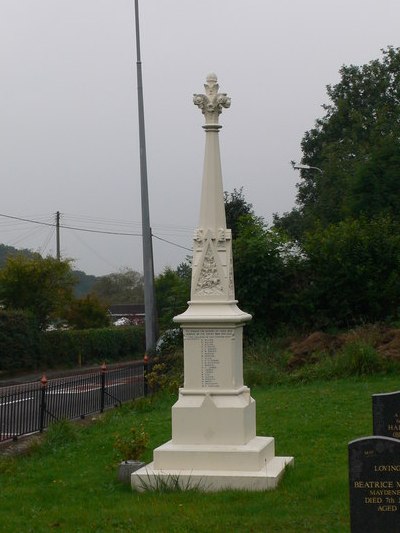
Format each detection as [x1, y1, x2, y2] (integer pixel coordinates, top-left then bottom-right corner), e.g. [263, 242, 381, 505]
[0, 361, 148, 442]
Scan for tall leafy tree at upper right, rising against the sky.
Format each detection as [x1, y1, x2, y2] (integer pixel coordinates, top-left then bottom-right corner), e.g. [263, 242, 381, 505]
[275, 47, 400, 238]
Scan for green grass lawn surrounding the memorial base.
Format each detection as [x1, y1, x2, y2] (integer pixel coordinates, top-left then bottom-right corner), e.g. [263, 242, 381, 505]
[0, 375, 399, 533]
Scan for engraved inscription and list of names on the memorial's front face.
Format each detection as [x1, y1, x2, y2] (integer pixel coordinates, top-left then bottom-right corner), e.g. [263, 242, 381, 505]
[185, 328, 235, 388]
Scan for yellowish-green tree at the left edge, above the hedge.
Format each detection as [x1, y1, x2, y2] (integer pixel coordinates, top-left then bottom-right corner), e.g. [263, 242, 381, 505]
[0, 255, 76, 329]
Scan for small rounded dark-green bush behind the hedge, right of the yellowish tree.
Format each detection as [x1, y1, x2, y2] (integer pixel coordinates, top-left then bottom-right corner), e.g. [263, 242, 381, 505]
[66, 294, 110, 329]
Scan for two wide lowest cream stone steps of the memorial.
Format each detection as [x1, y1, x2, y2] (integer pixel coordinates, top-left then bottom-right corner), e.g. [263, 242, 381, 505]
[131, 437, 293, 492]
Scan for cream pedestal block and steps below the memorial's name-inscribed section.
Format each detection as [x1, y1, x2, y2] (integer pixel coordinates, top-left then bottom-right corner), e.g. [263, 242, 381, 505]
[131, 386, 293, 491]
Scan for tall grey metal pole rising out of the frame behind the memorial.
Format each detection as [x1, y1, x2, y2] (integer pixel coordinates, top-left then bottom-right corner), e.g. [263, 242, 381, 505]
[135, 0, 157, 353]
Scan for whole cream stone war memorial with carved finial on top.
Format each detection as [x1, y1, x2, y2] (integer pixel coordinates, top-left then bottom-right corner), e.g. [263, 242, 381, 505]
[131, 74, 293, 491]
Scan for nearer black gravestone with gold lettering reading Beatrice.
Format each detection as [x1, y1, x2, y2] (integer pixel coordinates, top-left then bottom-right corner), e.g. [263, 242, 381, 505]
[349, 436, 400, 533]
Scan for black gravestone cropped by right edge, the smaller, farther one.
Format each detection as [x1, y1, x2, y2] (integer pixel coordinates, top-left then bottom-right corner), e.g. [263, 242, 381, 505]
[372, 392, 400, 438]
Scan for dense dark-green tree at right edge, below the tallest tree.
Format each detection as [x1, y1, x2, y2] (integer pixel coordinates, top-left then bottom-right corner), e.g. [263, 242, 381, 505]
[302, 216, 400, 327]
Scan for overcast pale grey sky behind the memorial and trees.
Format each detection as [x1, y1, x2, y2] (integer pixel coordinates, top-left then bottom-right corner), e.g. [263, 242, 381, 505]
[0, 0, 400, 275]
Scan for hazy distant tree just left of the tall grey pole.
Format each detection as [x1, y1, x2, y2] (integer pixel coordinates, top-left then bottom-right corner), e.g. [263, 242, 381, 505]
[92, 268, 144, 305]
